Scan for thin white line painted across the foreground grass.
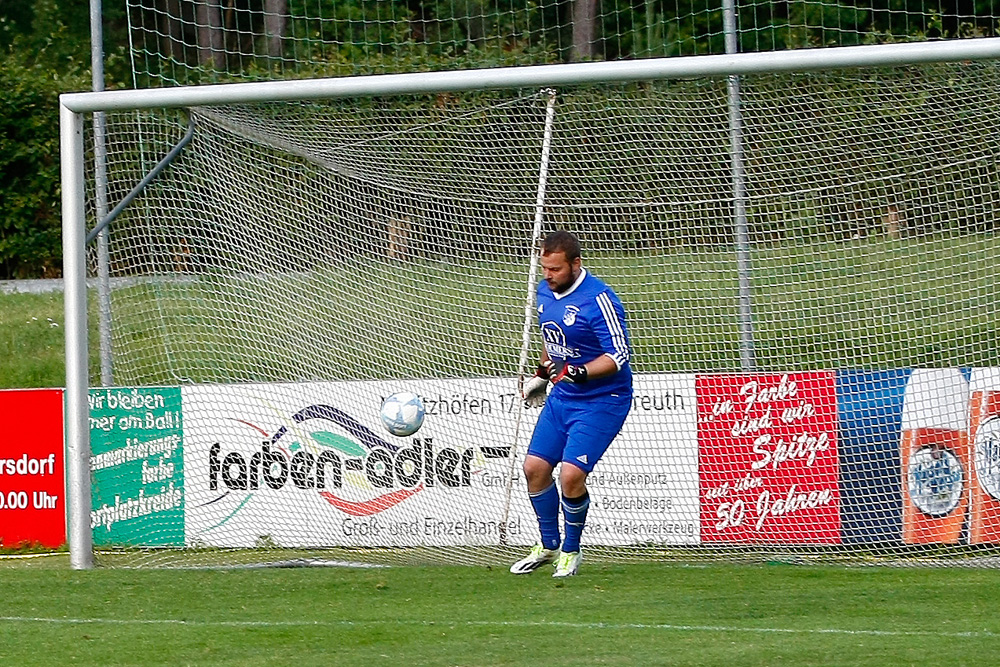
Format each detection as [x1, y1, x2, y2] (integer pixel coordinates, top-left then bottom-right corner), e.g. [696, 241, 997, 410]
[0, 616, 1000, 639]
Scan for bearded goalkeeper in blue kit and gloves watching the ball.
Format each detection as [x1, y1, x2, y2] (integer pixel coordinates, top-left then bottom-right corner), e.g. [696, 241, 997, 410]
[510, 231, 632, 577]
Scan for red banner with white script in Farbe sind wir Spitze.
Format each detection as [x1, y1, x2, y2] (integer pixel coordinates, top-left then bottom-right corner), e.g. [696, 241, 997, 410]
[695, 372, 841, 544]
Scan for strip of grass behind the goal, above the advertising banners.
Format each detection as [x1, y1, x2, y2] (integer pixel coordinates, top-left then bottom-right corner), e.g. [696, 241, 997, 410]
[7, 234, 1000, 387]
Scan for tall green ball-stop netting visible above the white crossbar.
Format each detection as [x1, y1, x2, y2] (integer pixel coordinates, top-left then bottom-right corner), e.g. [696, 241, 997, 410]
[126, 0, 998, 86]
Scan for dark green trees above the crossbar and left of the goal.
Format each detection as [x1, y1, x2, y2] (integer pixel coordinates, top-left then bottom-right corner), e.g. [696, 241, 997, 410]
[0, 0, 1000, 278]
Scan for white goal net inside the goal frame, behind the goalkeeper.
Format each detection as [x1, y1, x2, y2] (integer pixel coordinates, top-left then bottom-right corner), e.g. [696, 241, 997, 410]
[74, 51, 1000, 565]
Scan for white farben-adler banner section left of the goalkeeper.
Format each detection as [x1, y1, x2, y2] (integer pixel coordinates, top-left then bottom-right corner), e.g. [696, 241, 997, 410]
[183, 380, 537, 547]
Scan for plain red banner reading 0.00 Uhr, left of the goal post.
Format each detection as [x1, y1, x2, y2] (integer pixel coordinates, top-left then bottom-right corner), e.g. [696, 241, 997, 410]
[0, 389, 66, 547]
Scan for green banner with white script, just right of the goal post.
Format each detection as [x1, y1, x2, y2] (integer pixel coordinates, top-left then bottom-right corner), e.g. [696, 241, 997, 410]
[89, 387, 184, 546]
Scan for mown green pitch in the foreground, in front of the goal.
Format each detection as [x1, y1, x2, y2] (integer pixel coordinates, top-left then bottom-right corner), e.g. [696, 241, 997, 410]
[0, 556, 1000, 666]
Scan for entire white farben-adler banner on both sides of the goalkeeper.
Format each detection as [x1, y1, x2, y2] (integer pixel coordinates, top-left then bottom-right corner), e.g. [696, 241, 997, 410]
[182, 376, 698, 547]
